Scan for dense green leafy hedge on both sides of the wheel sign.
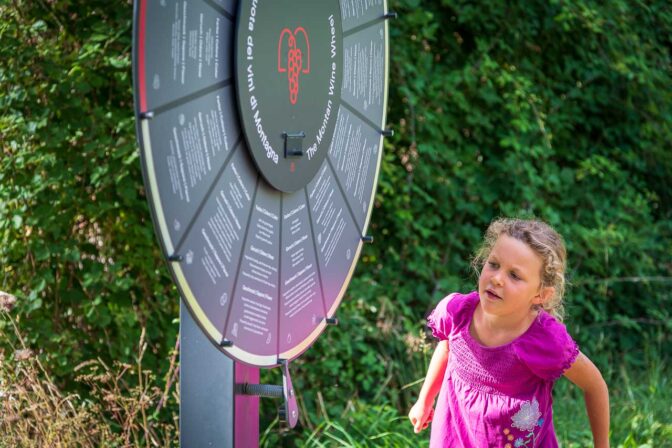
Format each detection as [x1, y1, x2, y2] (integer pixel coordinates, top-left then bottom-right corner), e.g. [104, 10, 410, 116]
[0, 0, 672, 442]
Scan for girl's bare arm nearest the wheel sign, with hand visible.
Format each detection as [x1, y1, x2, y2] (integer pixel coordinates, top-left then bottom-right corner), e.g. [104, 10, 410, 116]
[408, 341, 449, 433]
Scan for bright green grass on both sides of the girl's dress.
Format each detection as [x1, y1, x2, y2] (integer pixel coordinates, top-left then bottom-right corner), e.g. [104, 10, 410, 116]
[261, 359, 672, 448]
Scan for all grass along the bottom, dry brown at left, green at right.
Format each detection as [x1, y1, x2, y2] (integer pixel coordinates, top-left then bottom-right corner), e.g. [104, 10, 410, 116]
[0, 288, 672, 448]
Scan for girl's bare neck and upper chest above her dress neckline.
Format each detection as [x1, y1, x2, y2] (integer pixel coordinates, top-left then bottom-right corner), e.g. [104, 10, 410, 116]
[469, 303, 539, 347]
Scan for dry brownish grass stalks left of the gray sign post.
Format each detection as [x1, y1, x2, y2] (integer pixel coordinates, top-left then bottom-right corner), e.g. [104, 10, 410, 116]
[0, 299, 179, 448]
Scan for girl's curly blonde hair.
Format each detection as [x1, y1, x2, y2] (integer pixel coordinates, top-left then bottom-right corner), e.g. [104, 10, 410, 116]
[472, 218, 567, 322]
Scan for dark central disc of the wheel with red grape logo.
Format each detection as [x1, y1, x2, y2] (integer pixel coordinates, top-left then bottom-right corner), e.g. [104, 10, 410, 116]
[236, 0, 343, 192]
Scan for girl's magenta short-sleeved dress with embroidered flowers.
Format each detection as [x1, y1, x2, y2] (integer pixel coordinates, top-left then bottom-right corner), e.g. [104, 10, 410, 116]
[427, 291, 579, 448]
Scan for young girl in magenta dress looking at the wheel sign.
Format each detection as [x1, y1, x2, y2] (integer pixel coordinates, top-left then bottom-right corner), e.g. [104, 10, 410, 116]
[408, 219, 609, 448]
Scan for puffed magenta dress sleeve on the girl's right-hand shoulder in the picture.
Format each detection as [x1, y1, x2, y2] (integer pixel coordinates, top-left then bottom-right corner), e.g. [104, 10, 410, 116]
[514, 313, 579, 381]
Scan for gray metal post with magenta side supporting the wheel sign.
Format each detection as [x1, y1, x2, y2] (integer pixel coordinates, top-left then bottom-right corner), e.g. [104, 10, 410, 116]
[180, 301, 259, 448]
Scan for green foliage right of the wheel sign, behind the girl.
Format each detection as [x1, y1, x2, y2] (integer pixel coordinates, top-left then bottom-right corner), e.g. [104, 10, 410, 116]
[302, 0, 672, 428]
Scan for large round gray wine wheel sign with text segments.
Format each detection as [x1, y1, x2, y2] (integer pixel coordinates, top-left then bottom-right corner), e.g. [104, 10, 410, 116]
[133, 0, 388, 374]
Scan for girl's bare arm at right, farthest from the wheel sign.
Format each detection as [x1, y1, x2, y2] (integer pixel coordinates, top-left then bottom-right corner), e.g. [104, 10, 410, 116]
[565, 352, 609, 448]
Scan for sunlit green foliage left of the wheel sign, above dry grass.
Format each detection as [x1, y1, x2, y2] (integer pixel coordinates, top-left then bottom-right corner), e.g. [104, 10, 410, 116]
[0, 1, 178, 382]
